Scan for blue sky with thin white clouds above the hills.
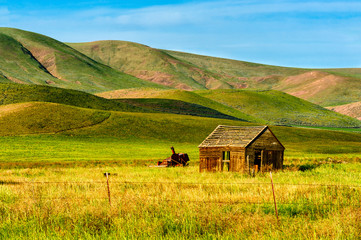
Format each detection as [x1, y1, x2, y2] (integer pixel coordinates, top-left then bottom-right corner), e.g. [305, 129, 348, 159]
[0, 0, 361, 68]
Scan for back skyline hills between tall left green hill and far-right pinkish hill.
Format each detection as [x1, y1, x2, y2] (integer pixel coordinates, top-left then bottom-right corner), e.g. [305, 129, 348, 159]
[68, 41, 305, 90]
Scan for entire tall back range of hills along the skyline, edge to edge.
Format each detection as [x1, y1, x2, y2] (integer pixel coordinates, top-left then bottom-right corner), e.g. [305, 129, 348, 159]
[0, 28, 361, 106]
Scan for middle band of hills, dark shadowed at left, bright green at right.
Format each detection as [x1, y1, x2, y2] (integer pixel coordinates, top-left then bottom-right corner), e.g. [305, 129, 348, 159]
[0, 83, 361, 127]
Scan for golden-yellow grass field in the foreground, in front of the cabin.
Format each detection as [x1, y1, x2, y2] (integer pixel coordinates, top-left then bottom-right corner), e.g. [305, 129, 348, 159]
[0, 162, 361, 239]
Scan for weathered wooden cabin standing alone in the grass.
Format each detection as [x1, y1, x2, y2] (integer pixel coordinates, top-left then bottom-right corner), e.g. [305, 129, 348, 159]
[199, 125, 285, 172]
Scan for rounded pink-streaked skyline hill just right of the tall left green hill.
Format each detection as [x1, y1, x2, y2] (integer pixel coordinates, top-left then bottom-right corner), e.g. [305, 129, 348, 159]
[68, 41, 231, 90]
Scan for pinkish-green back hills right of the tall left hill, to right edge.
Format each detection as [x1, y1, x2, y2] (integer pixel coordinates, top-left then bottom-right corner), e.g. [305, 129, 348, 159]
[69, 41, 361, 106]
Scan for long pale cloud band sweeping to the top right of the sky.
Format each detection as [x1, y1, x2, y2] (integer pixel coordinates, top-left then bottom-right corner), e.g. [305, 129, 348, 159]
[76, 0, 361, 27]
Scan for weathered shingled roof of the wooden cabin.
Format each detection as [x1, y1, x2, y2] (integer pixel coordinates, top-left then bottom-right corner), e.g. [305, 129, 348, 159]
[198, 125, 268, 147]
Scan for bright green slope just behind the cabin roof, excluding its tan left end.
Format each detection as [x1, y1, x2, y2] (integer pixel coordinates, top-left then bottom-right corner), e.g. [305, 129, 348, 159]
[196, 90, 361, 127]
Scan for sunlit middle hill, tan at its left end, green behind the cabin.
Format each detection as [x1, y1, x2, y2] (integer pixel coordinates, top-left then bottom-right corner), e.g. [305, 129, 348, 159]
[99, 89, 361, 127]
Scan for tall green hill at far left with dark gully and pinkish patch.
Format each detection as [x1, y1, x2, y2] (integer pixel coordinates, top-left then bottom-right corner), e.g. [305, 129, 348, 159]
[0, 28, 162, 92]
